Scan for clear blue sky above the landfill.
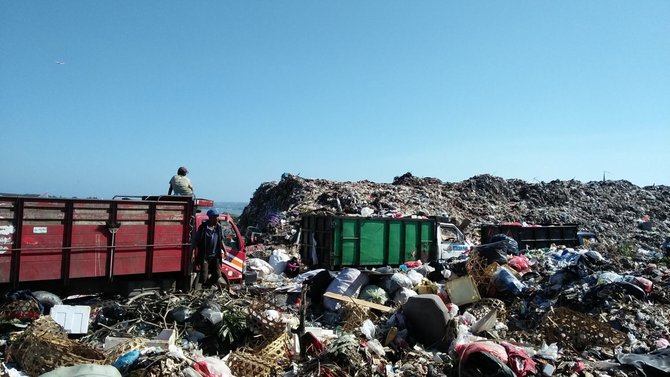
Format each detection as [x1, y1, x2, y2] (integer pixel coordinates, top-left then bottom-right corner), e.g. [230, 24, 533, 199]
[0, 0, 670, 201]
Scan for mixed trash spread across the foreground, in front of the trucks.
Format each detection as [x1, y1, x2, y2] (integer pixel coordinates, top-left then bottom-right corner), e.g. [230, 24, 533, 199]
[0, 238, 670, 377]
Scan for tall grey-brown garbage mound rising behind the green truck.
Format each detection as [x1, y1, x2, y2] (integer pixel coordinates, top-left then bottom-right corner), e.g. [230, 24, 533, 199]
[240, 173, 670, 250]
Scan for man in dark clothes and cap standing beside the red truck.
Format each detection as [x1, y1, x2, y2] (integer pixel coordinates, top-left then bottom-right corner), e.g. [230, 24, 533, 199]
[193, 208, 224, 288]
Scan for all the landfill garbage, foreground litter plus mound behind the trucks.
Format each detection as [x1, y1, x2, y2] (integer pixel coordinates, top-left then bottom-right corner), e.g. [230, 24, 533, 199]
[0, 174, 670, 377]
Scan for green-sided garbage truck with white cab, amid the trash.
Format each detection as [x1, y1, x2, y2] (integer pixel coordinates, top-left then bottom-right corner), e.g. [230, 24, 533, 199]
[299, 215, 471, 270]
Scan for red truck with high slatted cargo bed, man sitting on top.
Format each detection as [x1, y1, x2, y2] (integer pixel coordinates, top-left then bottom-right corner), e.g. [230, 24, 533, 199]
[0, 196, 245, 293]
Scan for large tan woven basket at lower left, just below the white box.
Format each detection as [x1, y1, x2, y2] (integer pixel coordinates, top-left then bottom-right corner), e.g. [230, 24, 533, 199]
[7, 317, 105, 376]
